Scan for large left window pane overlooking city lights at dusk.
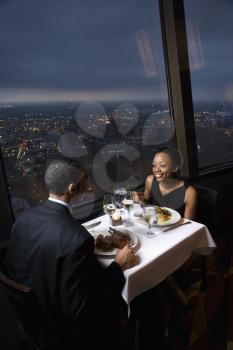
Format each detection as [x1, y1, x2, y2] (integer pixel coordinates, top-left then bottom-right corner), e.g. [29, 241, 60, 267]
[0, 0, 174, 219]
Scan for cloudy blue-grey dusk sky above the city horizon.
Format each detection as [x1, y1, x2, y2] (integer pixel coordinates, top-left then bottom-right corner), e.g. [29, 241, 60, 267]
[0, 0, 233, 103]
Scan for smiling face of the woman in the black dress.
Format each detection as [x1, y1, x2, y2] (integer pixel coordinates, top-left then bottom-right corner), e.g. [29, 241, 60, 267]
[152, 152, 177, 182]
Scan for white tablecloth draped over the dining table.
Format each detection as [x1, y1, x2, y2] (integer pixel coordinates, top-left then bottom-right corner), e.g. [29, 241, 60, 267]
[85, 211, 216, 304]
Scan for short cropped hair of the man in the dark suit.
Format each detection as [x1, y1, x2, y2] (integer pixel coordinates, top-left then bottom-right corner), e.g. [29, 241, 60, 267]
[44, 160, 85, 195]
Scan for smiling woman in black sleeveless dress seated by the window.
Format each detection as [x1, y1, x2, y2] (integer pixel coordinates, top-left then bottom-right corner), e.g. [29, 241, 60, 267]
[134, 148, 197, 220]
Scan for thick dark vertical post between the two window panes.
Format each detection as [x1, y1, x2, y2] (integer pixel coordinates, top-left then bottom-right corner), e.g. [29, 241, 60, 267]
[160, 0, 198, 178]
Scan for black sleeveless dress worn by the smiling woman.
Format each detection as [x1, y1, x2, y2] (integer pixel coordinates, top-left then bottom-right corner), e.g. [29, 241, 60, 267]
[151, 179, 188, 216]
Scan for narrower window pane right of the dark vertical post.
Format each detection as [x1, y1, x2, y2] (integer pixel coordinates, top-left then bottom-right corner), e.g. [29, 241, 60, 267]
[184, 0, 233, 170]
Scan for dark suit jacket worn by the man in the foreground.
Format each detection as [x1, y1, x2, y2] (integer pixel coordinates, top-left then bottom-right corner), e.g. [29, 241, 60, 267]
[5, 200, 125, 344]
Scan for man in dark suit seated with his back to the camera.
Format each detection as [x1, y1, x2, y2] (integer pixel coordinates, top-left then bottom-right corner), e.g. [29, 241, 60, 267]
[5, 160, 136, 350]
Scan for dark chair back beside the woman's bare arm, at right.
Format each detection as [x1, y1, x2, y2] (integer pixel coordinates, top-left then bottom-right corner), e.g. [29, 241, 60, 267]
[194, 185, 217, 233]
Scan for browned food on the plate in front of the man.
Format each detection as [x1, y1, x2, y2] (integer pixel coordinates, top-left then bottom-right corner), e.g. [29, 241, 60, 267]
[95, 228, 131, 252]
